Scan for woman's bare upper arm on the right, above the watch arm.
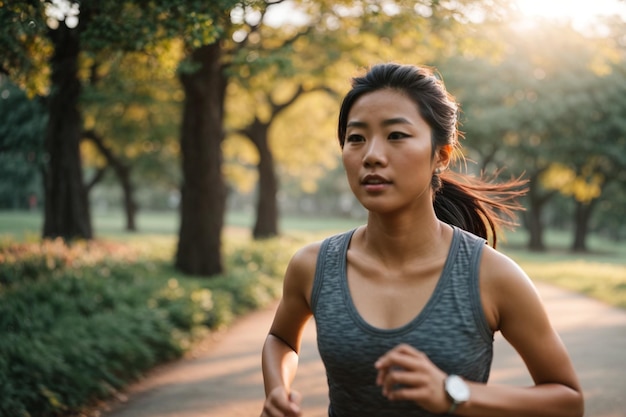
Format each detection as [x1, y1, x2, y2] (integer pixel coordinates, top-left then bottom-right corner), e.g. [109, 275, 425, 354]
[481, 249, 579, 389]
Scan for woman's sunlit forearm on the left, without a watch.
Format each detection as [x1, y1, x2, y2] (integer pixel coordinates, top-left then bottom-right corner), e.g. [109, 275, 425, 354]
[262, 334, 298, 395]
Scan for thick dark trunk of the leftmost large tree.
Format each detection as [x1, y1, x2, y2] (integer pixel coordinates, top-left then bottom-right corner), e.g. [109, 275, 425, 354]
[43, 23, 93, 240]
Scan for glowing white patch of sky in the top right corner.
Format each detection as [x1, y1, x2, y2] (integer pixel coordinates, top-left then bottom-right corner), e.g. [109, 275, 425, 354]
[515, 0, 626, 26]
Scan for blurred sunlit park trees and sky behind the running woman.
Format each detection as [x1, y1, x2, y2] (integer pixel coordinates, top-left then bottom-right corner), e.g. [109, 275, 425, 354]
[0, 0, 626, 275]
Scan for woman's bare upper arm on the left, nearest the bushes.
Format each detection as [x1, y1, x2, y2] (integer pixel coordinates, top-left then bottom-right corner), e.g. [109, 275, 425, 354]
[270, 243, 320, 352]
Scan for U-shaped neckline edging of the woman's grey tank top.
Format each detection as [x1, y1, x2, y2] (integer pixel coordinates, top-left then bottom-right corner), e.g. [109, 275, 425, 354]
[339, 225, 460, 335]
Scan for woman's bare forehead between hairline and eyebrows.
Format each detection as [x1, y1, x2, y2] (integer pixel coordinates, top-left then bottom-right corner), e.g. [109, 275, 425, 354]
[348, 88, 422, 121]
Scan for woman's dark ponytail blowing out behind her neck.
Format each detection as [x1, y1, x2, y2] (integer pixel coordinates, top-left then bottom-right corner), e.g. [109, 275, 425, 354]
[433, 171, 527, 248]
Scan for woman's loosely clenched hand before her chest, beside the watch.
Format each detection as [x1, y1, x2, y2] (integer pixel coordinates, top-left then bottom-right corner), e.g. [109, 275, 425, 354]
[375, 344, 451, 414]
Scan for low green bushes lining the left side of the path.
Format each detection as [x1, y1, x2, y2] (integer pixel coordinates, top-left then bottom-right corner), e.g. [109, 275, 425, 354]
[0, 239, 292, 417]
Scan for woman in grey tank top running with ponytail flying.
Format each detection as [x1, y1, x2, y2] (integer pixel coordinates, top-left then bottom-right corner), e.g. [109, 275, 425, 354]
[261, 64, 583, 417]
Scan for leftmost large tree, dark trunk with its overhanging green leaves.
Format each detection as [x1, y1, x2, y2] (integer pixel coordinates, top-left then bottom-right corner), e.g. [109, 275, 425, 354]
[0, 0, 221, 239]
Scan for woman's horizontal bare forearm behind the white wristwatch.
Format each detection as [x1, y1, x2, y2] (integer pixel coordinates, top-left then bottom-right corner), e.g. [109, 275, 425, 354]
[455, 383, 584, 417]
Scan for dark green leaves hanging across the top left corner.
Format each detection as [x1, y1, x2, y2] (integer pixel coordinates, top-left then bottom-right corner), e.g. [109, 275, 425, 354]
[0, 0, 240, 94]
